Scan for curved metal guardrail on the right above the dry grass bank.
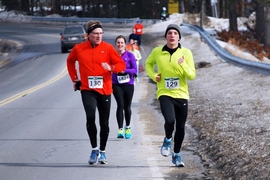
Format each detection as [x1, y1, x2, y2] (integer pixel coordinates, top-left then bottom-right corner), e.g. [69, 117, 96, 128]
[181, 23, 270, 71]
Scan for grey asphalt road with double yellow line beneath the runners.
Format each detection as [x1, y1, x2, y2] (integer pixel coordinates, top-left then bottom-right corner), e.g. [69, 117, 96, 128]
[0, 24, 206, 180]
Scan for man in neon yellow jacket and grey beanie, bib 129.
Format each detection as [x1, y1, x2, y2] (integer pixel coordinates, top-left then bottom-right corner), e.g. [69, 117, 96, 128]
[145, 24, 196, 167]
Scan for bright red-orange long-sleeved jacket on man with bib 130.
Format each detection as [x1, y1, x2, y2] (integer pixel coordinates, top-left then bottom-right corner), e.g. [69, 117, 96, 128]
[67, 41, 126, 95]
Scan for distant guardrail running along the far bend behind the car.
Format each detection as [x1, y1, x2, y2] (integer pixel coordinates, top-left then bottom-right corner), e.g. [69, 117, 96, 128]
[31, 16, 161, 26]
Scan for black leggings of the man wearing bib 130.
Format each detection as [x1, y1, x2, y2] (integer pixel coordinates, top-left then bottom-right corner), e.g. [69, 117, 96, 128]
[81, 90, 111, 151]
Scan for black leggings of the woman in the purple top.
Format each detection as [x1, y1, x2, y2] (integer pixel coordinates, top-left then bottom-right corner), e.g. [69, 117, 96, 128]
[113, 84, 134, 129]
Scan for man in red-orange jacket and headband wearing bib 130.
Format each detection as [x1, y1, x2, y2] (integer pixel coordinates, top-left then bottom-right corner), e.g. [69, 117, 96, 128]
[67, 21, 126, 165]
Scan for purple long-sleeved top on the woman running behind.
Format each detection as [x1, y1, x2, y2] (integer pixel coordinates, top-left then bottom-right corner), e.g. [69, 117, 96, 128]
[112, 51, 137, 85]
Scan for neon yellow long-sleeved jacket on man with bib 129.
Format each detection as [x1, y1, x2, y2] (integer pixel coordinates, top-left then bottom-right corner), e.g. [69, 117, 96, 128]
[145, 46, 196, 99]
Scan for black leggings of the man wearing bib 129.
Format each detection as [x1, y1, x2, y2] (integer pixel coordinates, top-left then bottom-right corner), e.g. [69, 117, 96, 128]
[159, 96, 188, 153]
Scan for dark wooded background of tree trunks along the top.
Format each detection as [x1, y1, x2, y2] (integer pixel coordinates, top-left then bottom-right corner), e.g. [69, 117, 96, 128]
[0, 0, 270, 47]
